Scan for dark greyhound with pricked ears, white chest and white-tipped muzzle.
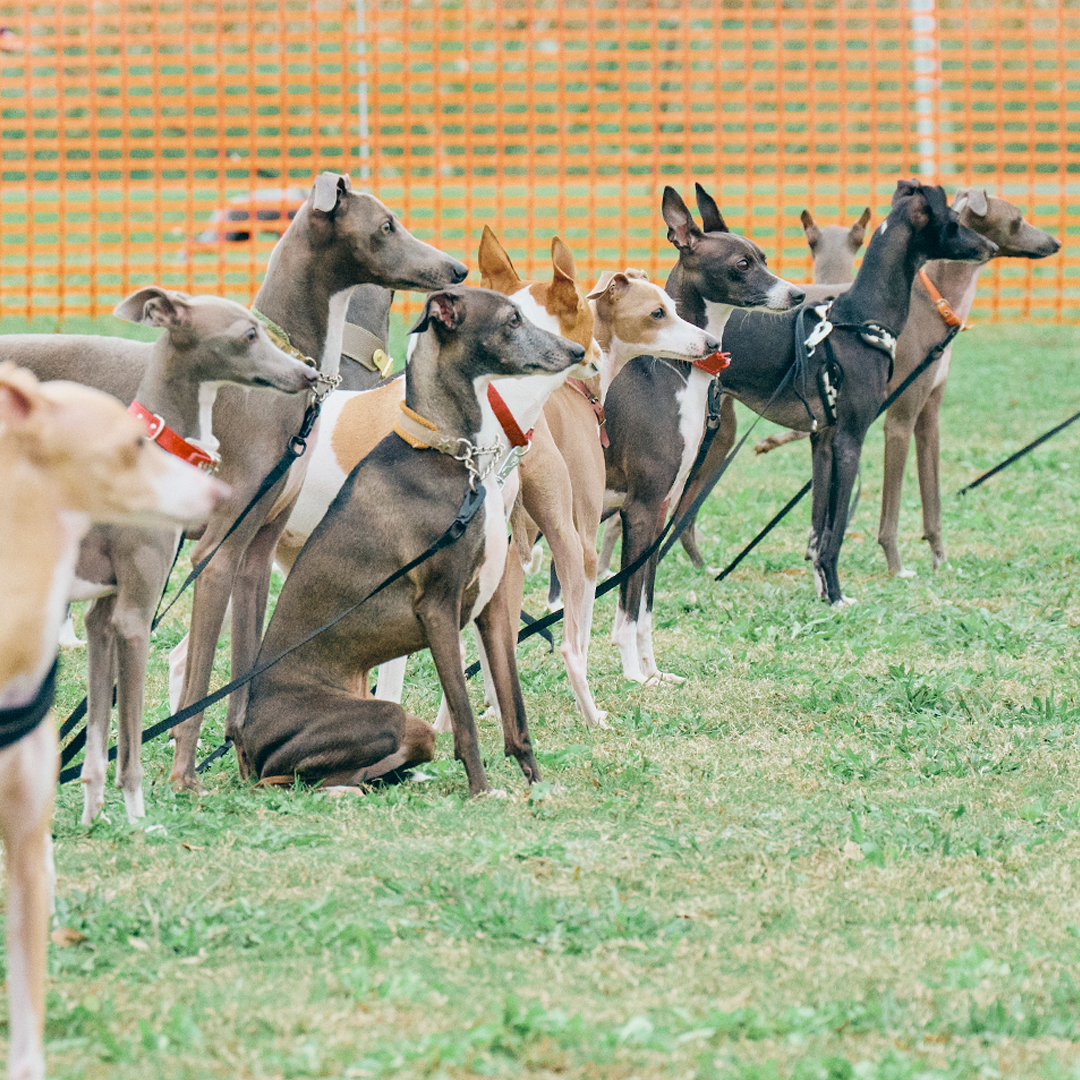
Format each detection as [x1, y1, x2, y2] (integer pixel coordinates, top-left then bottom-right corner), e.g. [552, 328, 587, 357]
[605, 184, 804, 685]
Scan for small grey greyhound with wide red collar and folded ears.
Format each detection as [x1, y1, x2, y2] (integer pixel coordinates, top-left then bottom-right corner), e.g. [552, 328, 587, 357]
[72, 287, 319, 825]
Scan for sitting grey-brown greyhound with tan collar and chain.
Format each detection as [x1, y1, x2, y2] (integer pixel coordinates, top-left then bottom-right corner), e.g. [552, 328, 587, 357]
[235, 288, 585, 795]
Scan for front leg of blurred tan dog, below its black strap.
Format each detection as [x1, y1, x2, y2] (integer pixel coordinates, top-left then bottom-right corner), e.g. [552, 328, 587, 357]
[0, 717, 58, 1080]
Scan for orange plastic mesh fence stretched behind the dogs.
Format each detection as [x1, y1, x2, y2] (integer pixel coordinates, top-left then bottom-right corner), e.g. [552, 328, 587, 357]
[0, 0, 1080, 322]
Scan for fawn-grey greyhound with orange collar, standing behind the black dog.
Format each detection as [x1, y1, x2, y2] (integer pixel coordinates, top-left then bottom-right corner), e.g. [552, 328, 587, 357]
[755, 188, 1062, 577]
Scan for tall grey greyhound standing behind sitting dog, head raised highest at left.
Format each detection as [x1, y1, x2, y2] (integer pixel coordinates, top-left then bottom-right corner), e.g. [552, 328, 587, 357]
[163, 173, 468, 791]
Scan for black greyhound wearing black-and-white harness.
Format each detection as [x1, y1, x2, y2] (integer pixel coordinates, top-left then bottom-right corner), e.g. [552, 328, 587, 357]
[720, 180, 998, 604]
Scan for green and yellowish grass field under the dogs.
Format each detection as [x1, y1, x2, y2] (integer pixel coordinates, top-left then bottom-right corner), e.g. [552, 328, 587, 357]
[12, 325, 1080, 1080]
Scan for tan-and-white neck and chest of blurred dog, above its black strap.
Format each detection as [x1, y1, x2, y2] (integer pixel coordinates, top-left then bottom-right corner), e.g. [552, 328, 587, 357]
[0, 455, 90, 708]
